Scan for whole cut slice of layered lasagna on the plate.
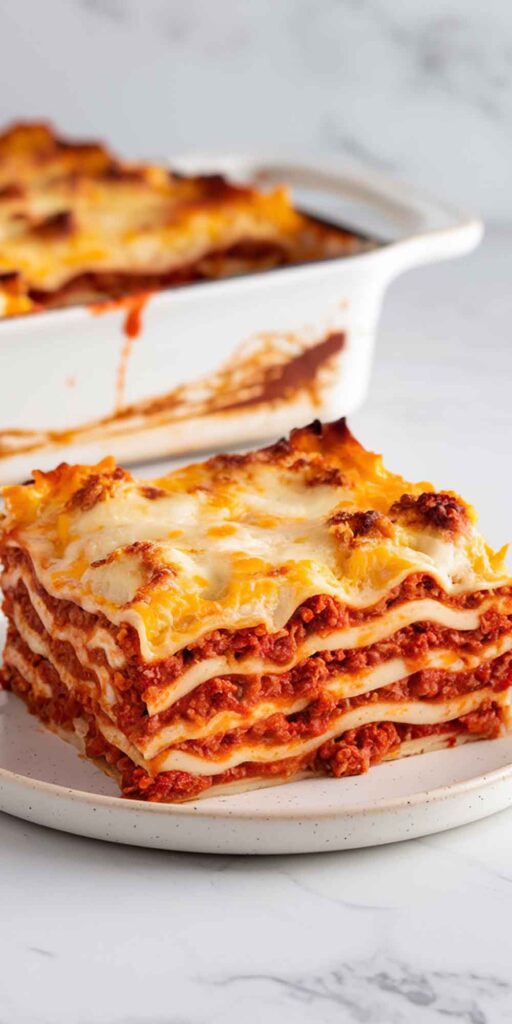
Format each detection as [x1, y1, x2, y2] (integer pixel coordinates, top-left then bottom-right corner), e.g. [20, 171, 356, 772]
[1, 421, 512, 802]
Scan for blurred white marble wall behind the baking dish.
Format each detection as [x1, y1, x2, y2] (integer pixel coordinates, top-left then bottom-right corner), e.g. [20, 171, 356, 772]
[0, 0, 512, 221]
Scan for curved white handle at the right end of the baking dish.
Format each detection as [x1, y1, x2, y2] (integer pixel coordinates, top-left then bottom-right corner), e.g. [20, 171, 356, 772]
[172, 155, 483, 280]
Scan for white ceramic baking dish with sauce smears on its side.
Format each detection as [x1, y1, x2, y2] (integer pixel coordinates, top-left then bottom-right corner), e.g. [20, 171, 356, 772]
[0, 157, 482, 481]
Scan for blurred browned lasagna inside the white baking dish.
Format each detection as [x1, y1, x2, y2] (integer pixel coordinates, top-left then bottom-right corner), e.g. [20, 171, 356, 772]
[0, 124, 364, 316]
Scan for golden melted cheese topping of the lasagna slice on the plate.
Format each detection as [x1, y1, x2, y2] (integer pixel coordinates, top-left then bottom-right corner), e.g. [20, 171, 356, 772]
[2, 421, 511, 660]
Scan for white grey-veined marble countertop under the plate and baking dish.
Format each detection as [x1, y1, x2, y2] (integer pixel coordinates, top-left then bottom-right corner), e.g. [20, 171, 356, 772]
[0, 230, 512, 1024]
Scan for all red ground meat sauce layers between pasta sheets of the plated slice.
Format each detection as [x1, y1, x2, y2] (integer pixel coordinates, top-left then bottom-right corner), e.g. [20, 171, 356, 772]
[4, 557, 512, 801]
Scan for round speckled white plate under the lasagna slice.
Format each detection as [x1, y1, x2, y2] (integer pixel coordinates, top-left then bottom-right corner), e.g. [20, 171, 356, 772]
[0, 671, 512, 854]
